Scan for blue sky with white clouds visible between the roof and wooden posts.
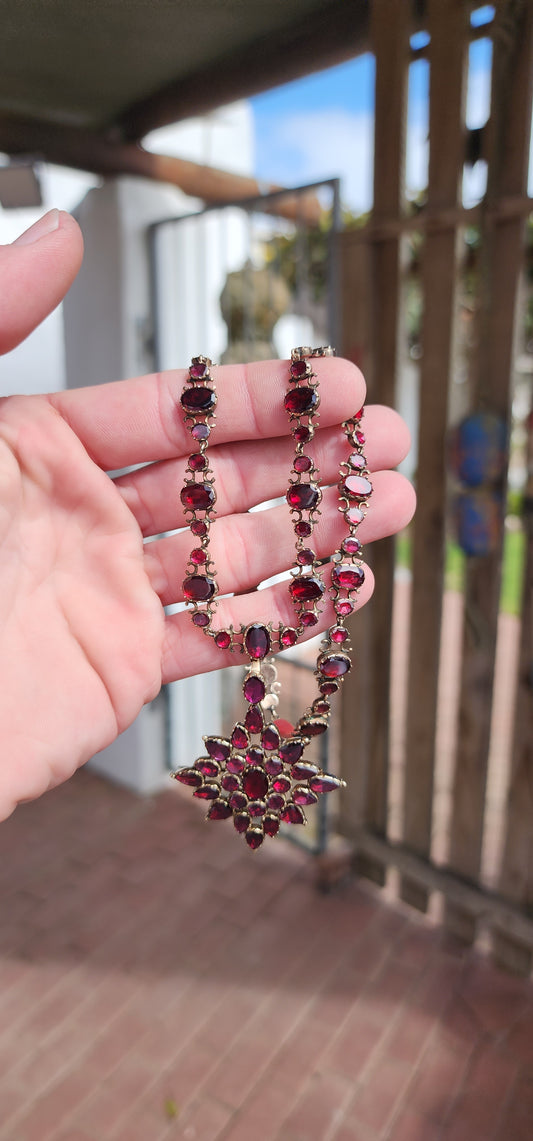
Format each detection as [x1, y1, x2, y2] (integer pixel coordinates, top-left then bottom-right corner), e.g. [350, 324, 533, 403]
[251, 6, 499, 211]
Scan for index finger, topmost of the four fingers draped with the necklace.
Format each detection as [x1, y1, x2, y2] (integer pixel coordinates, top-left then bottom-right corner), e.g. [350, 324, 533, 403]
[48, 357, 365, 471]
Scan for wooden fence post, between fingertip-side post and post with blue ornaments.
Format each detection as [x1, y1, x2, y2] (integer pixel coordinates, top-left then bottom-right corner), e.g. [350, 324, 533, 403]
[401, 0, 468, 911]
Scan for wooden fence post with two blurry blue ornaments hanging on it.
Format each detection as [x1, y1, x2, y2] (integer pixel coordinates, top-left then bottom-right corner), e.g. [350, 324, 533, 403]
[445, 0, 533, 941]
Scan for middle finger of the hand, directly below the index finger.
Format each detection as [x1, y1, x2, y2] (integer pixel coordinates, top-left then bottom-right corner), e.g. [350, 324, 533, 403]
[115, 405, 410, 535]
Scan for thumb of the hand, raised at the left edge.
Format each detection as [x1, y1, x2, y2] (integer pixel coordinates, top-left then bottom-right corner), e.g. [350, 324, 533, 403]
[0, 210, 83, 354]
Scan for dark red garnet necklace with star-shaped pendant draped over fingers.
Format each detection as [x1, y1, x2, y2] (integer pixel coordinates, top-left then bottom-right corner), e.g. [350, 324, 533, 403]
[172, 346, 372, 849]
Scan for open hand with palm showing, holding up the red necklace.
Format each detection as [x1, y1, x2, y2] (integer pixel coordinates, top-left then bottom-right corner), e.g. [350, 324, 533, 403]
[0, 215, 414, 819]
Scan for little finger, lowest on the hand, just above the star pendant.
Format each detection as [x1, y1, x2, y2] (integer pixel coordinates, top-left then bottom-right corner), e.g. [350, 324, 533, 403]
[161, 566, 374, 685]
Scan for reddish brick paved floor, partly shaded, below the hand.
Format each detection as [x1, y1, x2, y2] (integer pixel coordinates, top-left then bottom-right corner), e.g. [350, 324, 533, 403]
[0, 772, 533, 1141]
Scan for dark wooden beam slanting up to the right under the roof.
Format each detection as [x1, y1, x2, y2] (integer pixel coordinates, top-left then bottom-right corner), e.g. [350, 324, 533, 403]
[120, 0, 369, 139]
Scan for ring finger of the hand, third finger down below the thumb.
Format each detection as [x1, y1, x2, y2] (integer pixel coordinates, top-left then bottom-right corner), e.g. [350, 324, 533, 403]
[145, 471, 414, 607]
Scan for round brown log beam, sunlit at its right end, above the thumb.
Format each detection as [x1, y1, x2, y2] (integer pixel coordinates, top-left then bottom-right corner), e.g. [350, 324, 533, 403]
[0, 113, 322, 225]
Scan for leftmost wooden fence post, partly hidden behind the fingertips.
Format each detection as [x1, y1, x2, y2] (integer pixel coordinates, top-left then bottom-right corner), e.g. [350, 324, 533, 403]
[342, 0, 411, 883]
